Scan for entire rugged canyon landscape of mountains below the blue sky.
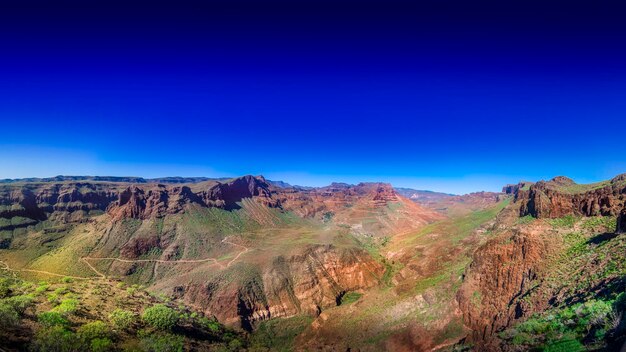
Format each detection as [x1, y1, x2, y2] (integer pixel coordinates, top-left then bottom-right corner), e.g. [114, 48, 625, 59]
[0, 175, 626, 351]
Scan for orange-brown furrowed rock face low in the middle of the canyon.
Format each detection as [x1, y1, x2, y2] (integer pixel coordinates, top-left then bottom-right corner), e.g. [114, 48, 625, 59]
[174, 245, 385, 329]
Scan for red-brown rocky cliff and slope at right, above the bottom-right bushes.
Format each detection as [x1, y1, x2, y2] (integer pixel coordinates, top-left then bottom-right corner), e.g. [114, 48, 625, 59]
[457, 175, 626, 351]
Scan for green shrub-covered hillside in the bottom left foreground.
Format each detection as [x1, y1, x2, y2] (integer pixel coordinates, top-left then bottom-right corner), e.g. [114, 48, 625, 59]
[0, 272, 248, 352]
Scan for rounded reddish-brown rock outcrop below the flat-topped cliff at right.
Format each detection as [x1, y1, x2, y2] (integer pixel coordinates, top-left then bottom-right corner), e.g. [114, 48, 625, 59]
[457, 227, 558, 350]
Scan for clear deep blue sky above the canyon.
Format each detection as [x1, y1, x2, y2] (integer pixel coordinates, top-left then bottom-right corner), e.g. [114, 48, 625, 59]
[0, 1, 626, 193]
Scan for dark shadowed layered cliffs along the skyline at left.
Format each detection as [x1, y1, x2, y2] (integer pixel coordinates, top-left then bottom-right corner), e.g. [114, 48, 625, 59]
[0, 176, 280, 226]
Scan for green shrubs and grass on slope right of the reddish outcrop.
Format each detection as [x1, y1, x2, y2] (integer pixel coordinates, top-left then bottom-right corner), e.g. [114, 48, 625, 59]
[501, 216, 626, 351]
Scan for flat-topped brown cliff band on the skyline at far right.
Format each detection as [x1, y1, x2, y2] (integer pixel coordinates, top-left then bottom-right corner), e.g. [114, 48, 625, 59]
[515, 174, 626, 218]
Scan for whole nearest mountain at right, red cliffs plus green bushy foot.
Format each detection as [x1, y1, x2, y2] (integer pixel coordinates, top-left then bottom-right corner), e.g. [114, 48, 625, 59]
[457, 174, 626, 351]
